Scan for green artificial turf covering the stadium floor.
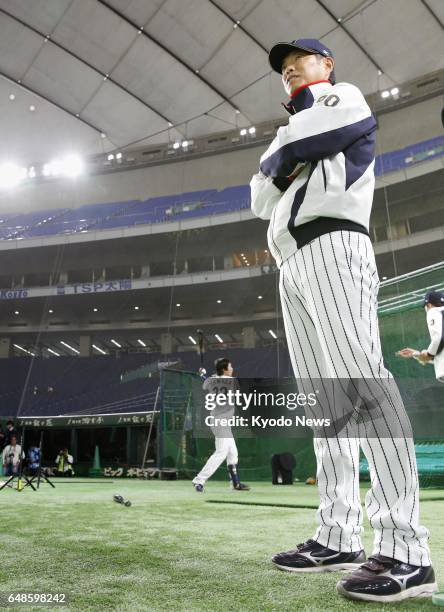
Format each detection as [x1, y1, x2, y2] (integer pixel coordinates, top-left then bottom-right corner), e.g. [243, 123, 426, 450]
[0, 480, 444, 612]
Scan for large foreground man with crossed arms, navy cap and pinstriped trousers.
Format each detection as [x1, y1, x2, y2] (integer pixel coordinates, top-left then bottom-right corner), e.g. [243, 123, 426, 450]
[251, 39, 437, 602]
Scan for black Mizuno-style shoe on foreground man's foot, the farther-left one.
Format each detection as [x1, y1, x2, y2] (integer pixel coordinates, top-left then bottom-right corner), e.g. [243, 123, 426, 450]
[271, 540, 366, 573]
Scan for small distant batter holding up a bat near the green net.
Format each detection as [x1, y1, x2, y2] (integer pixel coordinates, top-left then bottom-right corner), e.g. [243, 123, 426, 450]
[193, 357, 250, 493]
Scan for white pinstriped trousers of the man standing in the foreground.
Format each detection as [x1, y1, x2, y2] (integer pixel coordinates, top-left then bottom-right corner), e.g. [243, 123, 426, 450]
[280, 231, 430, 566]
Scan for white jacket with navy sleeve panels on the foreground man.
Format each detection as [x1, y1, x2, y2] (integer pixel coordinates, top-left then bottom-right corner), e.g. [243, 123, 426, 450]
[250, 81, 376, 266]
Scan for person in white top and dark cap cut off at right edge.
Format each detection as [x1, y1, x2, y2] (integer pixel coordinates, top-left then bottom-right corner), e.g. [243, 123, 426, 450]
[397, 291, 444, 382]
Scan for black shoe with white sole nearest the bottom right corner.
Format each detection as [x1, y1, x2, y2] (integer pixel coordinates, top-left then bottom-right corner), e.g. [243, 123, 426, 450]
[336, 555, 438, 603]
